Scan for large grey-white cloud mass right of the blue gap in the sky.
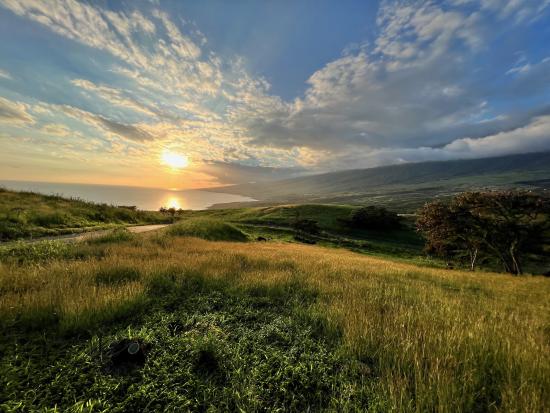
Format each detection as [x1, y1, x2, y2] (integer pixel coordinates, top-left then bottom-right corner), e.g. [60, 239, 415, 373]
[239, 1, 550, 168]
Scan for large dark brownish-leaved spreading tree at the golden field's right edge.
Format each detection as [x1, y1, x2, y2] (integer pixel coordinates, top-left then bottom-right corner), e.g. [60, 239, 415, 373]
[417, 191, 550, 274]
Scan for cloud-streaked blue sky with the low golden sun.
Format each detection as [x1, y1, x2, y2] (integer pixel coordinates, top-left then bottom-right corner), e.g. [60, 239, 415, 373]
[0, 0, 550, 189]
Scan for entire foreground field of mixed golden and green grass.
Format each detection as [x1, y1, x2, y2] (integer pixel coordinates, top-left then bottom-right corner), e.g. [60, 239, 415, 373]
[0, 226, 550, 412]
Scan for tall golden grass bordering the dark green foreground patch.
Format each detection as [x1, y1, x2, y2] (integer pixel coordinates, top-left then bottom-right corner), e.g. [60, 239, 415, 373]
[0, 235, 550, 412]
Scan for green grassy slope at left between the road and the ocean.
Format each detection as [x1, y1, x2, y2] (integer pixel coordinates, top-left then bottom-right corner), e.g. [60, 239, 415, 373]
[0, 188, 171, 241]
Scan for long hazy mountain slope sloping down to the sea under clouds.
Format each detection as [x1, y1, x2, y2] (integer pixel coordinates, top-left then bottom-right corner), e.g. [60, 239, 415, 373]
[209, 152, 550, 212]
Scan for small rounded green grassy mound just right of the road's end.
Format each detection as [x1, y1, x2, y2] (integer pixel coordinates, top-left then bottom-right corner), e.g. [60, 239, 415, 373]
[166, 217, 248, 242]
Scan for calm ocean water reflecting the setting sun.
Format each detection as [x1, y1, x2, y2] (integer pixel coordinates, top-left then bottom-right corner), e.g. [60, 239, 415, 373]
[0, 180, 255, 211]
